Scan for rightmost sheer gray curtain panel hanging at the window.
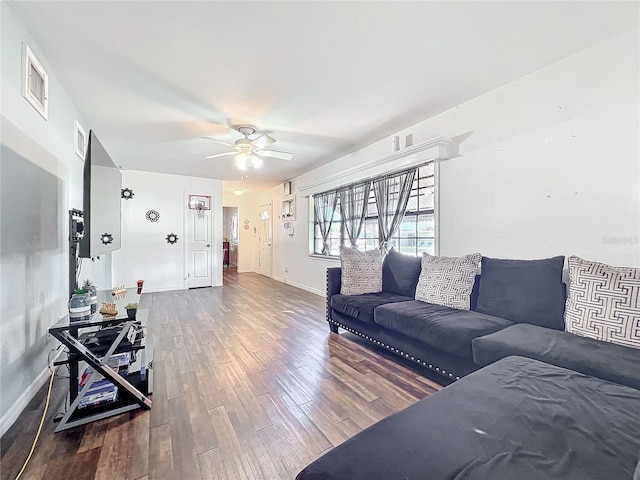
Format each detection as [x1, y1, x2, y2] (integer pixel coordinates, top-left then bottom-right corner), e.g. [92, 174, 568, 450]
[373, 169, 417, 254]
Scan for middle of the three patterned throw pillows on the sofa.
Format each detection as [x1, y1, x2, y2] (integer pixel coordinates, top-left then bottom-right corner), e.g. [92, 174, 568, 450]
[415, 253, 482, 310]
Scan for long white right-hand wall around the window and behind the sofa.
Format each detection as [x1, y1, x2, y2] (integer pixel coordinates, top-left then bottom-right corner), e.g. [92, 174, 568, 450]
[255, 29, 640, 294]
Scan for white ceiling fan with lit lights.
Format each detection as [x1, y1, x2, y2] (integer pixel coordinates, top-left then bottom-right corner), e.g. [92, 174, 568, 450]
[202, 125, 293, 170]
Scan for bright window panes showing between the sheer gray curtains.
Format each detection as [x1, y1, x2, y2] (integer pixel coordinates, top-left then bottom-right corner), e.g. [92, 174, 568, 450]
[313, 162, 435, 256]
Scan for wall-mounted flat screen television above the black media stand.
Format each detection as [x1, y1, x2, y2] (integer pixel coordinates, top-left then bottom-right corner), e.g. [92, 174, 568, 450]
[78, 131, 122, 258]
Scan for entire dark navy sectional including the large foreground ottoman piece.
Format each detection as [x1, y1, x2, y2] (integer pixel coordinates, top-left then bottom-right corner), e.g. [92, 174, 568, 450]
[296, 252, 640, 480]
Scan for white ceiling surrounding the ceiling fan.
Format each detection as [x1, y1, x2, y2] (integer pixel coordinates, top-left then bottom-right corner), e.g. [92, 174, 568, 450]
[10, 1, 638, 192]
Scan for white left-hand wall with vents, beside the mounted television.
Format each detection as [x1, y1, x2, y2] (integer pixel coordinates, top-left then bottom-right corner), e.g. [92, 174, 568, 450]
[0, 2, 106, 434]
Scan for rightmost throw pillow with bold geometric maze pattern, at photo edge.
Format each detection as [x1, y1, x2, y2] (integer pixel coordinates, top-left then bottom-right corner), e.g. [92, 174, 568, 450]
[564, 256, 640, 348]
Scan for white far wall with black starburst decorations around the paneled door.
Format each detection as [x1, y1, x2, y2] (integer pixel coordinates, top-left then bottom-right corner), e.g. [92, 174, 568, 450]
[112, 170, 222, 292]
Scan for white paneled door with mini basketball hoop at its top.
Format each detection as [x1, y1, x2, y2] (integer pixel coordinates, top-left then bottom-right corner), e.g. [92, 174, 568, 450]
[187, 194, 212, 288]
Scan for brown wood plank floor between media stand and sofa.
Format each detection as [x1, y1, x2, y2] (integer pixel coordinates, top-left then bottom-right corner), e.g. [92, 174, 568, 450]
[0, 270, 441, 480]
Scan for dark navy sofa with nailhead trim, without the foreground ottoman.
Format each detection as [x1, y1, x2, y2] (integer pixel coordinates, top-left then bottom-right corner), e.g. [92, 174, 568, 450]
[327, 251, 640, 389]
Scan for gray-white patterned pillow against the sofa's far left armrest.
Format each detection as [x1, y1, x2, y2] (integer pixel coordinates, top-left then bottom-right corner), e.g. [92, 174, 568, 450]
[340, 247, 382, 295]
